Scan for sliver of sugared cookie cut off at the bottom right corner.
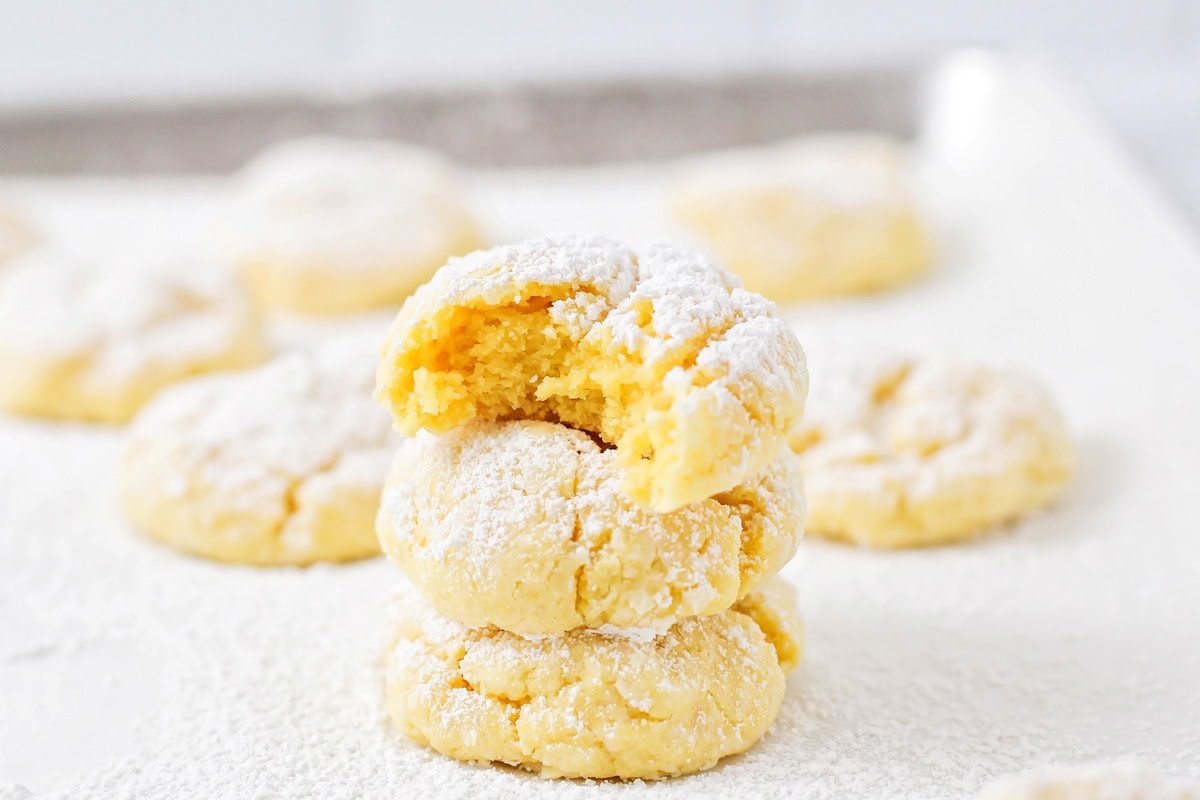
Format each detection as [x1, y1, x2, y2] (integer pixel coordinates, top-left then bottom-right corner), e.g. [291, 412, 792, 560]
[979, 760, 1200, 800]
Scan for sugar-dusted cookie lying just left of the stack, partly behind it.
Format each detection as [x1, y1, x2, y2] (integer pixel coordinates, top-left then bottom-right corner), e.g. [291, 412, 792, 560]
[120, 341, 391, 565]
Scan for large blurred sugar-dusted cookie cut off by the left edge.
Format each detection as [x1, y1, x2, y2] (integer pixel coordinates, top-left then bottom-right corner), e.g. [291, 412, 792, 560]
[0, 251, 266, 422]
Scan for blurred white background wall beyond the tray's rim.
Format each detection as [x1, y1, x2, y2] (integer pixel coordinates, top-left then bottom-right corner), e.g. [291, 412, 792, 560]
[0, 0, 1200, 209]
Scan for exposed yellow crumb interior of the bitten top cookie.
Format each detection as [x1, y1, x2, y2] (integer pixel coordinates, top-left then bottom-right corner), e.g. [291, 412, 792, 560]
[382, 287, 728, 511]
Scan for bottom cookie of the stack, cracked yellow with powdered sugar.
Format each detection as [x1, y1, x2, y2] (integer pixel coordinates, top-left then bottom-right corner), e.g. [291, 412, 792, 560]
[388, 578, 802, 778]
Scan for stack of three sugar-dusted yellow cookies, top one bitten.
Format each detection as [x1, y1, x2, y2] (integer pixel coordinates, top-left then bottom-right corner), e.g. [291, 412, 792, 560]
[377, 237, 808, 778]
